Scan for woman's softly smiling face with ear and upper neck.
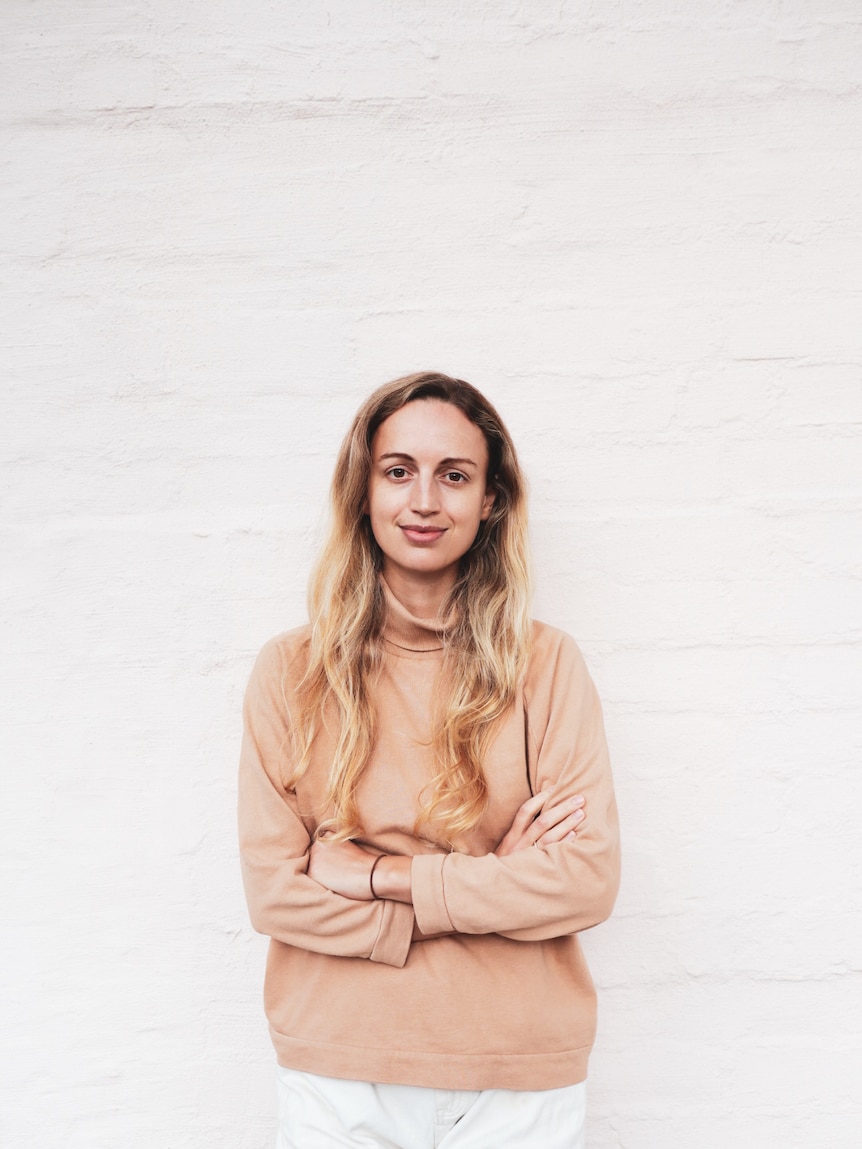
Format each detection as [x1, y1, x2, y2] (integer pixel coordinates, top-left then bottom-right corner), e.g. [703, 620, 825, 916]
[367, 399, 494, 593]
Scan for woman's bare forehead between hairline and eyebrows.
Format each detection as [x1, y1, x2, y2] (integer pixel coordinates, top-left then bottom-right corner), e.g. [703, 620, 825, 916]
[371, 399, 488, 466]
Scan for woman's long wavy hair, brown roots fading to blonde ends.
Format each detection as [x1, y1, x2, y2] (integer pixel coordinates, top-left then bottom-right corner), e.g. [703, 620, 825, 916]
[288, 372, 531, 846]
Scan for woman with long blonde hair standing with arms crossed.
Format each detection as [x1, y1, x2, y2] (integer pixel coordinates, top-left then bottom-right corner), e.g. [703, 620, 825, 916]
[239, 373, 618, 1149]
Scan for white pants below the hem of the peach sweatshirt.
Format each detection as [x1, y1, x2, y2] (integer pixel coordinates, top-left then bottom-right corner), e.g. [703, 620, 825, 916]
[277, 1065, 586, 1149]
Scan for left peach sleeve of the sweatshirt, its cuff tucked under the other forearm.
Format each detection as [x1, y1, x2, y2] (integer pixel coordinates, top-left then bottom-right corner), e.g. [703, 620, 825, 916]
[239, 639, 414, 966]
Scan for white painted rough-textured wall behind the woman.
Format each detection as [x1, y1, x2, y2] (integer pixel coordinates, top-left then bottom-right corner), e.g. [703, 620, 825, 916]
[0, 0, 862, 1149]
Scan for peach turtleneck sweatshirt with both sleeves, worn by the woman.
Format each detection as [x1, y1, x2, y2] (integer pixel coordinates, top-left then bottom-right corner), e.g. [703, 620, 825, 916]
[239, 584, 619, 1089]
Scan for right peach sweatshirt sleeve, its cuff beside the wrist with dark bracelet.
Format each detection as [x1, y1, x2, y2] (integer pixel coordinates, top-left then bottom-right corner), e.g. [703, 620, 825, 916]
[411, 627, 619, 941]
